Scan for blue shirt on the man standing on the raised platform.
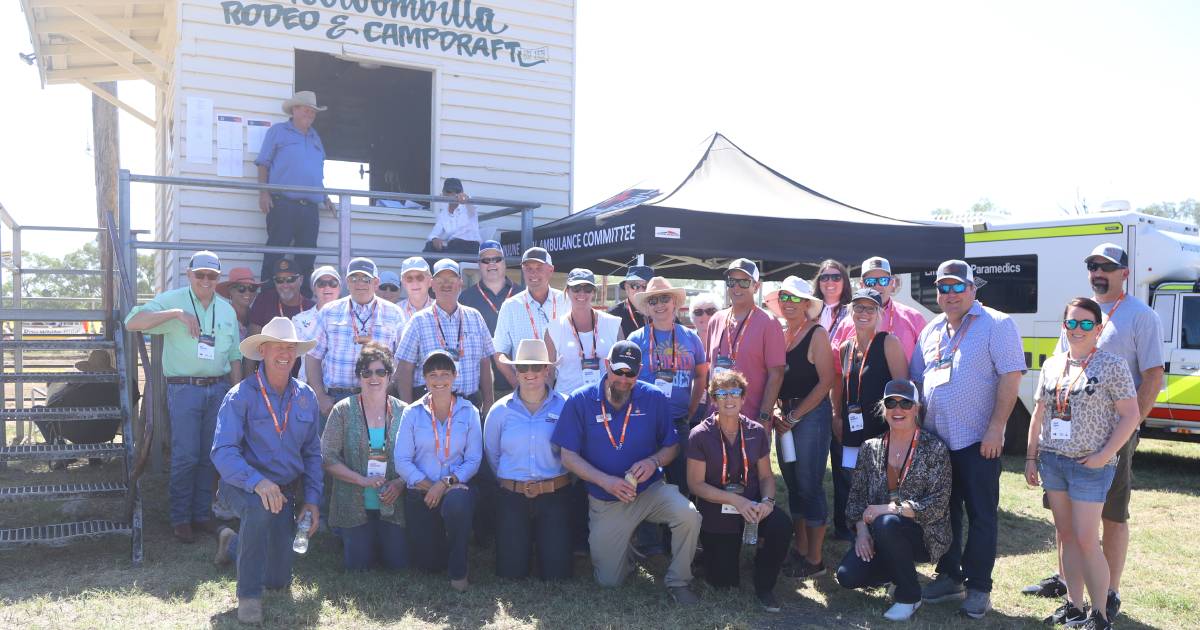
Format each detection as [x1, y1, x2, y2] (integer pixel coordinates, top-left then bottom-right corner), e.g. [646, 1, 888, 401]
[254, 119, 325, 204]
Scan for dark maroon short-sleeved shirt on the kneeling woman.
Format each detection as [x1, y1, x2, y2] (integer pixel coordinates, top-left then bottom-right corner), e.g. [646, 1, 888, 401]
[688, 415, 770, 534]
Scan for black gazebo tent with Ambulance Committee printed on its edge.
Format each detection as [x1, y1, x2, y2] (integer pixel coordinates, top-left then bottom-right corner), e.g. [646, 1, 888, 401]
[502, 133, 964, 280]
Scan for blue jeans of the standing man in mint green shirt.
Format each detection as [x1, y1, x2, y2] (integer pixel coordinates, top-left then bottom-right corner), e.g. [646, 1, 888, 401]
[167, 380, 229, 526]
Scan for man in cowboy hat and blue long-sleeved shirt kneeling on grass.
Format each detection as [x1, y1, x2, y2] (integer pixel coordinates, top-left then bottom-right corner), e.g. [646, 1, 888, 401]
[212, 317, 323, 623]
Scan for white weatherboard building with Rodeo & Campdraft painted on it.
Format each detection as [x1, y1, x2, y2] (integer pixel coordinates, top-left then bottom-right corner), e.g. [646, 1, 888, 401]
[20, 0, 575, 284]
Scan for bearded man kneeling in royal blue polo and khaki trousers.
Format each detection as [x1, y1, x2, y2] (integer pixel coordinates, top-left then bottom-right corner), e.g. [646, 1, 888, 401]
[551, 341, 700, 605]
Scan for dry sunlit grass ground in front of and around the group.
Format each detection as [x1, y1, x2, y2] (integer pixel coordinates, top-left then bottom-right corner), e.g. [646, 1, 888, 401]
[0, 440, 1200, 629]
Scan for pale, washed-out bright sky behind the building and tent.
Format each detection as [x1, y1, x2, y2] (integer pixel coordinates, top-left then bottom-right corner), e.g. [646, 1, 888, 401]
[0, 0, 1200, 250]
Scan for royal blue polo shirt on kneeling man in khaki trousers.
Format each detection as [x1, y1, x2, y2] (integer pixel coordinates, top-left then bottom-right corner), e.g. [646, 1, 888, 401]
[550, 376, 678, 500]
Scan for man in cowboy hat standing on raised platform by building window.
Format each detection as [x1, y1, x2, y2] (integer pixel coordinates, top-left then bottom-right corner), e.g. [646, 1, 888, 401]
[254, 91, 332, 298]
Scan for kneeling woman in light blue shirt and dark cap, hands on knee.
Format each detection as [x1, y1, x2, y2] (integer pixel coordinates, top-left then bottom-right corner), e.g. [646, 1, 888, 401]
[395, 349, 484, 592]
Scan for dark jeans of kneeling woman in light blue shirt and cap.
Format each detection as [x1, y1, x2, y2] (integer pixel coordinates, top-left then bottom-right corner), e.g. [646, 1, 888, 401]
[404, 487, 475, 580]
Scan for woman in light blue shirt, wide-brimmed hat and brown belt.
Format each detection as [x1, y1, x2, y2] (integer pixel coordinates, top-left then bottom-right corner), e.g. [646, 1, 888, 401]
[484, 340, 571, 580]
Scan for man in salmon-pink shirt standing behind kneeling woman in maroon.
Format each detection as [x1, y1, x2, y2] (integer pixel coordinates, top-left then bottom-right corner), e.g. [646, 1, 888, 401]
[708, 258, 787, 426]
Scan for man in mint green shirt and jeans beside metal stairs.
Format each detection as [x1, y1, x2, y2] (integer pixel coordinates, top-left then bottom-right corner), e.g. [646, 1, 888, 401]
[125, 251, 242, 542]
